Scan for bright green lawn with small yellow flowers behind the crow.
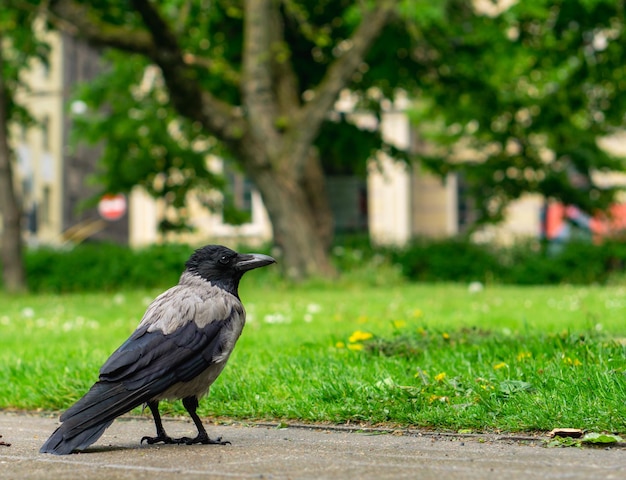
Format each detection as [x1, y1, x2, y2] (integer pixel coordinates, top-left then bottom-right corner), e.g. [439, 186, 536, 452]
[0, 274, 626, 433]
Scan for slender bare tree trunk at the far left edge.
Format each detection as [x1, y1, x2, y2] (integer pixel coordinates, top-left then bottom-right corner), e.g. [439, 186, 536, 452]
[0, 44, 26, 292]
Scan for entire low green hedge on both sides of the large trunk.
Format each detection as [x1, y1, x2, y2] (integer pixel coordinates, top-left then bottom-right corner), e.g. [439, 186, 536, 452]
[4, 236, 626, 293]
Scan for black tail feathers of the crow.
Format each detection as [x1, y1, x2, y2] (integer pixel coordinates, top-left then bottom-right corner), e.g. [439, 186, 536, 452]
[39, 382, 149, 455]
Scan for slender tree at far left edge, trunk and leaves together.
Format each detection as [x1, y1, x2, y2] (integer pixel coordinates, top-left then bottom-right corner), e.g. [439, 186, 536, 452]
[0, 8, 47, 292]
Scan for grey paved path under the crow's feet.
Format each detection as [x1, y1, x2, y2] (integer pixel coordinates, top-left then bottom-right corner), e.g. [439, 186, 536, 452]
[0, 413, 626, 480]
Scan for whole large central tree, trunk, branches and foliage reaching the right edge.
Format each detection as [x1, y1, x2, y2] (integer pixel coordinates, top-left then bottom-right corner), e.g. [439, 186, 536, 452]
[12, 0, 626, 278]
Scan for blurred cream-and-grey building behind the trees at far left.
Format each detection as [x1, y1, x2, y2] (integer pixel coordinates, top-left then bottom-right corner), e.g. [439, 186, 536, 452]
[11, 34, 128, 245]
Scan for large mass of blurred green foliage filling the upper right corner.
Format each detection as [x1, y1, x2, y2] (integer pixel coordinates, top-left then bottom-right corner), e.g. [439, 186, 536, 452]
[412, 0, 626, 224]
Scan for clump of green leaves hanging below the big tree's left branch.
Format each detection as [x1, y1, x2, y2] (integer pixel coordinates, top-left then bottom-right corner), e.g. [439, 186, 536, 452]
[72, 52, 225, 231]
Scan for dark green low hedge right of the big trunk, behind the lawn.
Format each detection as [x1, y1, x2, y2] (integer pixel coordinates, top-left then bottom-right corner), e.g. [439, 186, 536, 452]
[389, 238, 626, 285]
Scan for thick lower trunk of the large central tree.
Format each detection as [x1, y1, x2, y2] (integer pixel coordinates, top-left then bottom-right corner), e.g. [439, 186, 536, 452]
[253, 169, 336, 281]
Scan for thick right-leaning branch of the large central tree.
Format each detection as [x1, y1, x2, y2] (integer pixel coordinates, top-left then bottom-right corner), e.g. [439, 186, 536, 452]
[284, 0, 398, 178]
